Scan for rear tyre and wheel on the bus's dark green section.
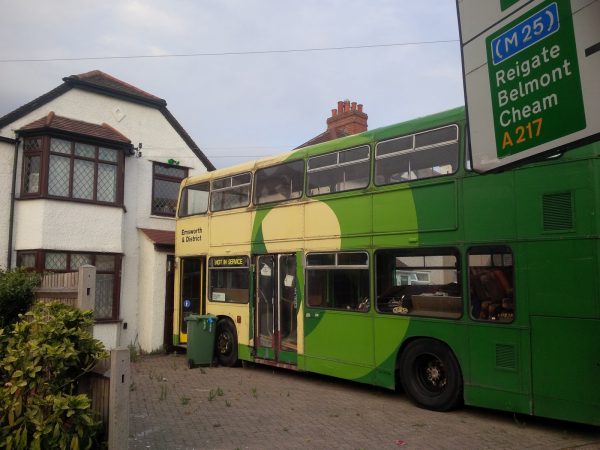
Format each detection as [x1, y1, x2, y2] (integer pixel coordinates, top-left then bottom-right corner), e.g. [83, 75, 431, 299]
[399, 339, 463, 411]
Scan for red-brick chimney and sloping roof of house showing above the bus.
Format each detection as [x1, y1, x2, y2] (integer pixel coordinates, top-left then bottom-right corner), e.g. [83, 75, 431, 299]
[296, 100, 369, 149]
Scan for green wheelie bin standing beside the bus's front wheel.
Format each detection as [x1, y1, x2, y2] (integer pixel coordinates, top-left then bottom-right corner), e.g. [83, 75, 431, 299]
[185, 314, 217, 369]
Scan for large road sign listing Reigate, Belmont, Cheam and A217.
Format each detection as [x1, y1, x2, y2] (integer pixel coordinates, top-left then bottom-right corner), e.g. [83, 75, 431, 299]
[457, 0, 600, 172]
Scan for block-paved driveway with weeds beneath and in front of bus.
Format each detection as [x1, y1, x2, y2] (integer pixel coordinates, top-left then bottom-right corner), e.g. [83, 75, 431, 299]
[129, 355, 600, 450]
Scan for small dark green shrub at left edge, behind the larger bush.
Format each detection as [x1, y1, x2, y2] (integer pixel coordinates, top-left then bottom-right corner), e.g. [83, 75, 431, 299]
[0, 269, 41, 328]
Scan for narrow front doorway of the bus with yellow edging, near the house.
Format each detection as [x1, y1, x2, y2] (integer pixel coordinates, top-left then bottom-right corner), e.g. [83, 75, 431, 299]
[177, 256, 206, 344]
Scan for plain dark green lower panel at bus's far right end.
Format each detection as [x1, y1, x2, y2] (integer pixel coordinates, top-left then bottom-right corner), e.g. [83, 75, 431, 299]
[531, 317, 600, 425]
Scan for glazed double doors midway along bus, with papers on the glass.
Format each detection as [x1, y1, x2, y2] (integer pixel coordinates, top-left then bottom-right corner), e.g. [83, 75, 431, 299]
[255, 254, 298, 364]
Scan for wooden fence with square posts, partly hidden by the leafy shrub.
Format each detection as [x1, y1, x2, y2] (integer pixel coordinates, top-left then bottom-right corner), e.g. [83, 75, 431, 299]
[35, 266, 130, 450]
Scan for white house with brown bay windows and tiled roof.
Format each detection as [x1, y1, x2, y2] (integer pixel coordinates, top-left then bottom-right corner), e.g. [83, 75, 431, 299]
[0, 70, 214, 351]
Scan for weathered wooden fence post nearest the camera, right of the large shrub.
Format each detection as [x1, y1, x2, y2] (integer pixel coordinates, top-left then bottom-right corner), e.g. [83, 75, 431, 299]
[108, 347, 130, 450]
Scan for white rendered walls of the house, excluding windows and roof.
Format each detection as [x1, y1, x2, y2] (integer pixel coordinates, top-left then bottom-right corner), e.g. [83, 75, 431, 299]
[0, 89, 206, 351]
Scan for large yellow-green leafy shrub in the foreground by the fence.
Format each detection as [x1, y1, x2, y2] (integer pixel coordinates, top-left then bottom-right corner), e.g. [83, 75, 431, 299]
[0, 303, 107, 449]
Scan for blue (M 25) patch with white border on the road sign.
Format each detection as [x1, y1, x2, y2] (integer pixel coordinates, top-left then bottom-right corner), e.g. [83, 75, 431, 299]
[491, 3, 560, 65]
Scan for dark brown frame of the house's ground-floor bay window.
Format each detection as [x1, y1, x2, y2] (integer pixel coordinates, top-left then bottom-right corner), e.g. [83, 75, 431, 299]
[17, 249, 123, 323]
